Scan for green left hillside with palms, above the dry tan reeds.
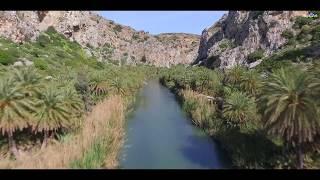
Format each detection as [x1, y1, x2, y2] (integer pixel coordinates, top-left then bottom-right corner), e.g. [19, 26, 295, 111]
[0, 27, 153, 165]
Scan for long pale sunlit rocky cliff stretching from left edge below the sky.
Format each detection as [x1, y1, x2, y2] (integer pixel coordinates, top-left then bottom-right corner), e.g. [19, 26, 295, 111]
[0, 11, 200, 66]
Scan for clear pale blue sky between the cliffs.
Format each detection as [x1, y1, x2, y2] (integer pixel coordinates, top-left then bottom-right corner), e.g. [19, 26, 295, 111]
[98, 11, 227, 35]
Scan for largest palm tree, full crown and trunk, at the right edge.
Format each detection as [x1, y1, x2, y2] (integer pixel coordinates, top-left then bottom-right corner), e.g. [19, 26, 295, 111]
[258, 68, 320, 168]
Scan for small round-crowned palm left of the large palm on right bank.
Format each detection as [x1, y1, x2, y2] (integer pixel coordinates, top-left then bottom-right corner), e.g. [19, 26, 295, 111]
[223, 91, 257, 128]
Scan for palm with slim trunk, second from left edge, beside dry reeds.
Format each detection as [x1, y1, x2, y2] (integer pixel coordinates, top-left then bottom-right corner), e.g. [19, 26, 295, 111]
[33, 86, 71, 148]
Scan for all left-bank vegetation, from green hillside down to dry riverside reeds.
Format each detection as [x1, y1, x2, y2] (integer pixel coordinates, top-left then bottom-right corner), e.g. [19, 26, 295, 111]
[0, 28, 154, 168]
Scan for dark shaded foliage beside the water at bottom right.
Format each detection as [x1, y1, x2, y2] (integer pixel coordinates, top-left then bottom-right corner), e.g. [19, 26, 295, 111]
[218, 129, 286, 169]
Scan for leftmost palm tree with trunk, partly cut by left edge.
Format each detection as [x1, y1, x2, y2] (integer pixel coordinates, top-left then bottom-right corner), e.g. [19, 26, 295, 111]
[0, 77, 34, 157]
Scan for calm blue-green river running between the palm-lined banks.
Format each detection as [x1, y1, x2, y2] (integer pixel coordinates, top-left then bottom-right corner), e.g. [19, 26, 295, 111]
[120, 80, 229, 169]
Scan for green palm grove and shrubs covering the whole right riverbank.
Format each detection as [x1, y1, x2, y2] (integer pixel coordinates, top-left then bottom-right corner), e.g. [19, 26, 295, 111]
[160, 13, 320, 168]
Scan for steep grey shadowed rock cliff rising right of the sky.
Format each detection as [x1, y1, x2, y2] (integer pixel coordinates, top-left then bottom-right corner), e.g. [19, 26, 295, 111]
[194, 11, 308, 68]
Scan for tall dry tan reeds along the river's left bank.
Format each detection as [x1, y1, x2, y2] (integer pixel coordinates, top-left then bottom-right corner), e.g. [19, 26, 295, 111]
[0, 96, 125, 169]
